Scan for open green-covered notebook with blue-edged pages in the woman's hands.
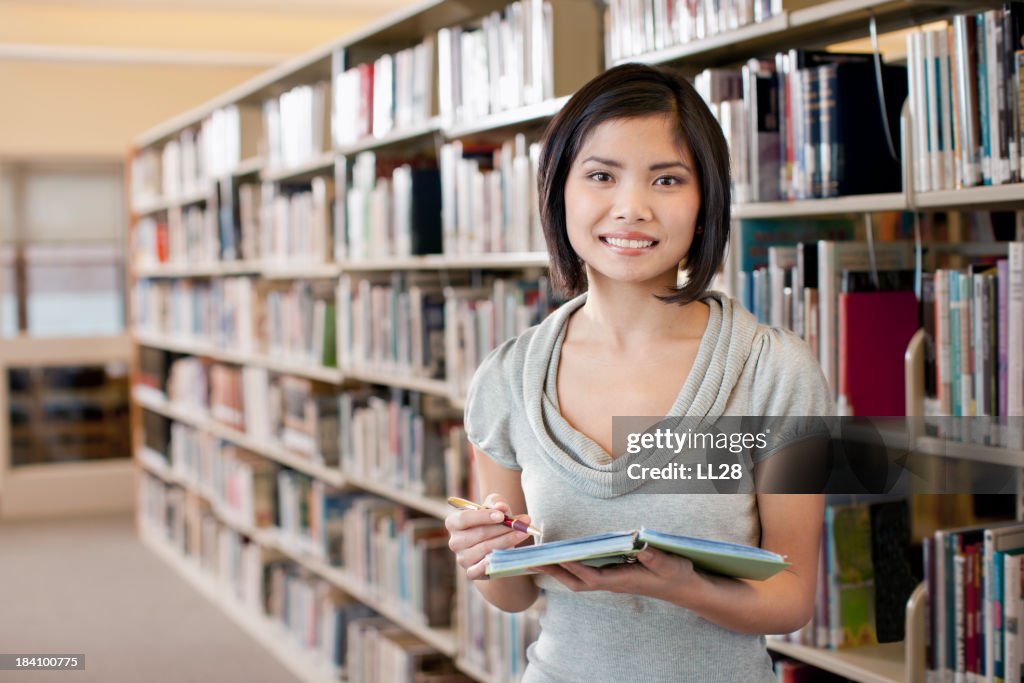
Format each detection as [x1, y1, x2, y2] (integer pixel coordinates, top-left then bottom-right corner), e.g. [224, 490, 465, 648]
[487, 527, 790, 581]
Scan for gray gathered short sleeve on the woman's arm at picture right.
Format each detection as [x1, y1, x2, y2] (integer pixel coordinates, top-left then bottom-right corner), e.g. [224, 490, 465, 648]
[752, 328, 836, 460]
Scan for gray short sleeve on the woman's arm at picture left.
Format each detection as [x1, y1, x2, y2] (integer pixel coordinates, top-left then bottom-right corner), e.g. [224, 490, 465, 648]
[465, 340, 522, 470]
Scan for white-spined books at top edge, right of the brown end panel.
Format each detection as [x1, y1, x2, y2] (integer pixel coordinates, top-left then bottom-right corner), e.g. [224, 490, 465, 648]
[605, 0, 782, 63]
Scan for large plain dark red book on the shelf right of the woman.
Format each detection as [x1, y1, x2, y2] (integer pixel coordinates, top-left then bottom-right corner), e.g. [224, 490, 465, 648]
[839, 292, 919, 417]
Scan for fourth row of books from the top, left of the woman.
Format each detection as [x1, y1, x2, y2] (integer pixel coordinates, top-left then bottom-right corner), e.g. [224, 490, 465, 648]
[139, 356, 472, 498]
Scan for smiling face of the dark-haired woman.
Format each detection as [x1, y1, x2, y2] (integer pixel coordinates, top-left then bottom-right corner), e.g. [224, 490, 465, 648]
[565, 115, 700, 288]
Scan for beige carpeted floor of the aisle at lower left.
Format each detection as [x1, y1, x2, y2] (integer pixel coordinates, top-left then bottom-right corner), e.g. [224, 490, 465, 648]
[0, 514, 296, 683]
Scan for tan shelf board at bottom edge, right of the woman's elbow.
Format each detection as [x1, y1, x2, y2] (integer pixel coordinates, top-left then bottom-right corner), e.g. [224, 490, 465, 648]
[768, 638, 906, 683]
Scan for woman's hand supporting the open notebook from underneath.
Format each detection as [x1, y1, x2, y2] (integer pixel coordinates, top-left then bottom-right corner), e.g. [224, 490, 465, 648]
[538, 548, 703, 606]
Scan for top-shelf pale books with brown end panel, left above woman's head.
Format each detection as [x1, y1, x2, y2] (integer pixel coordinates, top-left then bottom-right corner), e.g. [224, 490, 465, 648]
[437, 0, 601, 125]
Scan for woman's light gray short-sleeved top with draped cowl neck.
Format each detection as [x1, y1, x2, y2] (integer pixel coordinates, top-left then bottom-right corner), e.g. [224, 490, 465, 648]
[466, 292, 833, 683]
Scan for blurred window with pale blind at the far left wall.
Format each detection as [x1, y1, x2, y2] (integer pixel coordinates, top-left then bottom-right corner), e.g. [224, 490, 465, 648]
[0, 162, 125, 337]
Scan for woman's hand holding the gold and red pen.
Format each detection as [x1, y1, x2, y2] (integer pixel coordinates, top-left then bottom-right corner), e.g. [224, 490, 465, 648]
[444, 494, 530, 579]
